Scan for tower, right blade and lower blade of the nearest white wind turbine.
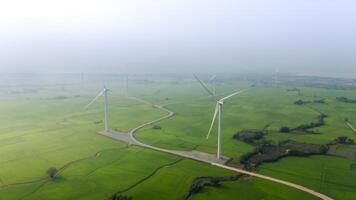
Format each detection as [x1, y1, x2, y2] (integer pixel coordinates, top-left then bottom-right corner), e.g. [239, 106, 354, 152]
[206, 90, 246, 160]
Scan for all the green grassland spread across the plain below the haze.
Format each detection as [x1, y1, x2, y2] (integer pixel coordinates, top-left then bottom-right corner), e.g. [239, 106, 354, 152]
[0, 76, 356, 200]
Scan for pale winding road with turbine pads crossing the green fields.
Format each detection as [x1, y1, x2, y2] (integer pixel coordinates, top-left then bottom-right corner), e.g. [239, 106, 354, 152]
[100, 97, 333, 200]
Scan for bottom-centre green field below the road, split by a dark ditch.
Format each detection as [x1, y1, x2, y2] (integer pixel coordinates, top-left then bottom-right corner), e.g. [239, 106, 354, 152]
[125, 160, 315, 200]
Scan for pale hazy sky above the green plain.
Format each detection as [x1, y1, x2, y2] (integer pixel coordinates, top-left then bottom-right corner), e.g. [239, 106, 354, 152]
[0, 0, 356, 75]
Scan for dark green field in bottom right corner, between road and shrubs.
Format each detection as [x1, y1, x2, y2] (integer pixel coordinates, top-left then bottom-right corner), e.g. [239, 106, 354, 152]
[259, 156, 356, 200]
